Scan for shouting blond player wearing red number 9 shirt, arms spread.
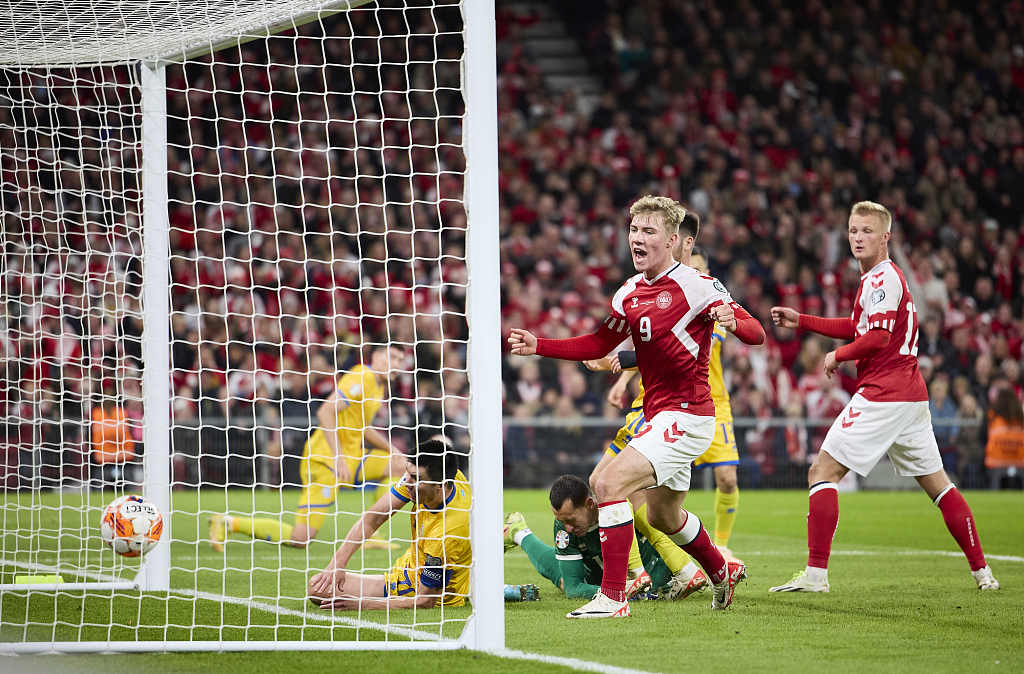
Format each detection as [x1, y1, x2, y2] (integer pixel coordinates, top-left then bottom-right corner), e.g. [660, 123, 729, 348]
[509, 196, 765, 618]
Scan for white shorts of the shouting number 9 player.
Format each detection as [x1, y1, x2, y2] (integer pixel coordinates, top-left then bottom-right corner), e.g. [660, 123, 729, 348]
[630, 411, 715, 492]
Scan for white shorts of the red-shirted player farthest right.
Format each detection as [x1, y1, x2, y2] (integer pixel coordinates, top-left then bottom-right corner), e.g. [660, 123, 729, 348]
[821, 393, 942, 477]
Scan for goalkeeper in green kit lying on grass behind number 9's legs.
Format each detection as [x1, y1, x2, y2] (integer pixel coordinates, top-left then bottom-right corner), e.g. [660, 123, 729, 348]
[505, 475, 708, 599]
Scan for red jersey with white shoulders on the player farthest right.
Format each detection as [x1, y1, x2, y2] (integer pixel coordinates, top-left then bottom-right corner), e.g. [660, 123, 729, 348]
[850, 260, 928, 403]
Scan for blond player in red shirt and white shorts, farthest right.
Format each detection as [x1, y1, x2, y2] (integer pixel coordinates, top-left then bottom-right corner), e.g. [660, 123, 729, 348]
[771, 201, 999, 592]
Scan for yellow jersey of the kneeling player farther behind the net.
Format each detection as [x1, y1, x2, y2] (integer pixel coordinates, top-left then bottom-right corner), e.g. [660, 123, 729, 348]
[303, 365, 384, 467]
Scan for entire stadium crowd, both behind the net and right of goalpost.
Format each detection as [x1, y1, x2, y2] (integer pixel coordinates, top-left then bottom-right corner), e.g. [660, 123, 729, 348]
[0, 0, 1024, 486]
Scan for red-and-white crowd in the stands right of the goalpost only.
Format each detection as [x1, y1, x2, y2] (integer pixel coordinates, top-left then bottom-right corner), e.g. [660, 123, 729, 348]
[499, 0, 1024, 486]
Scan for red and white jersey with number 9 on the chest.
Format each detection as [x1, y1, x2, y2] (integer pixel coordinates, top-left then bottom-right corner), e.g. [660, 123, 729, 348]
[605, 263, 732, 413]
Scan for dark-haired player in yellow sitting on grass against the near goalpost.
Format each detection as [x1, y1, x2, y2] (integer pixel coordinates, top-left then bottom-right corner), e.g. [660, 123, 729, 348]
[307, 440, 473, 610]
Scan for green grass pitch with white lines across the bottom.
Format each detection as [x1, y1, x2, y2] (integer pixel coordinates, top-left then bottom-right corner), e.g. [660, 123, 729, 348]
[0, 491, 1024, 672]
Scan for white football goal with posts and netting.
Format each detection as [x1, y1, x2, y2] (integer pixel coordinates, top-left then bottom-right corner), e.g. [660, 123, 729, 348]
[0, 0, 504, 651]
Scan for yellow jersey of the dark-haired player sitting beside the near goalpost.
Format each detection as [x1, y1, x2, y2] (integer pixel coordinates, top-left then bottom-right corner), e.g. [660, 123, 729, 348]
[388, 470, 473, 606]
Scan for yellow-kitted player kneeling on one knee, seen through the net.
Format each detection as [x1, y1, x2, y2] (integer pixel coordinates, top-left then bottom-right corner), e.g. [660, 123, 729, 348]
[210, 345, 406, 552]
